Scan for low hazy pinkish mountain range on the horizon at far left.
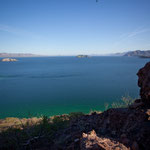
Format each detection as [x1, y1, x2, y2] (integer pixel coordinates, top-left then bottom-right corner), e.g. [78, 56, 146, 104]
[0, 53, 42, 57]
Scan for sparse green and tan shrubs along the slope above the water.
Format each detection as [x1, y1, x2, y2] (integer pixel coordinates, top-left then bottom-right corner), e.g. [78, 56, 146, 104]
[0, 96, 134, 149]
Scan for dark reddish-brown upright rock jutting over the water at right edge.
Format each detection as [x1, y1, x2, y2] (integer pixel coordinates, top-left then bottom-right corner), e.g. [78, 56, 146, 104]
[137, 62, 150, 104]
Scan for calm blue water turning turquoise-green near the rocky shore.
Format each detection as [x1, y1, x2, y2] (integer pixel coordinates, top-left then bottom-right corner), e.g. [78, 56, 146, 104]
[0, 57, 149, 118]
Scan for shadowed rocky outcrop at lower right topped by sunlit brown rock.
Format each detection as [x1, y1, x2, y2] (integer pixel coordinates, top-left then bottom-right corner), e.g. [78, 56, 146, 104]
[52, 108, 150, 150]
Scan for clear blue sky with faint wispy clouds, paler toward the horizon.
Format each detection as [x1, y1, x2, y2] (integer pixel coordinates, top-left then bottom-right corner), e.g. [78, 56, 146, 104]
[0, 0, 150, 55]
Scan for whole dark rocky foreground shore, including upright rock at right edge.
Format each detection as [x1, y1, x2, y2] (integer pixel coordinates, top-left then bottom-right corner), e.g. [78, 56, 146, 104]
[0, 62, 150, 150]
